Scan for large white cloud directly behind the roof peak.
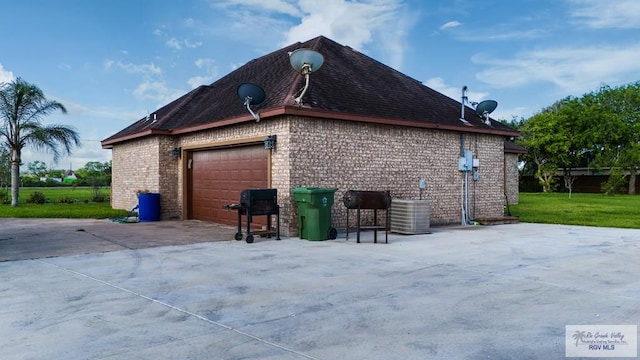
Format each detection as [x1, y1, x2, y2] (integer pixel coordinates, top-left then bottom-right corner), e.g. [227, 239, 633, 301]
[216, 0, 417, 69]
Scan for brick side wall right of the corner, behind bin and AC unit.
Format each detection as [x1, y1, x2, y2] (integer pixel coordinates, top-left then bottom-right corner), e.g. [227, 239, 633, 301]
[290, 118, 504, 231]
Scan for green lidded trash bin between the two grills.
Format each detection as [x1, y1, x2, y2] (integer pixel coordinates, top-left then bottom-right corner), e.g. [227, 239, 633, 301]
[293, 187, 338, 241]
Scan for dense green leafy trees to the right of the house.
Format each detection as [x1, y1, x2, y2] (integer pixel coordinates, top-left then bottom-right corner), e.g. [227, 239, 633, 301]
[509, 81, 640, 196]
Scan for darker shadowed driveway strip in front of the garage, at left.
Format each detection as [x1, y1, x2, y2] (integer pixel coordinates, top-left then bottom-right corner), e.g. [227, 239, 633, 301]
[0, 218, 236, 262]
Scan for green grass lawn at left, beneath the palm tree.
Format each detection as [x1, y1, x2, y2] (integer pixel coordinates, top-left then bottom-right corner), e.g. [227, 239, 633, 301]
[0, 187, 128, 219]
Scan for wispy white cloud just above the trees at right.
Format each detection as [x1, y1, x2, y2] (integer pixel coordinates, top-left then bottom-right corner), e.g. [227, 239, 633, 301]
[472, 43, 640, 94]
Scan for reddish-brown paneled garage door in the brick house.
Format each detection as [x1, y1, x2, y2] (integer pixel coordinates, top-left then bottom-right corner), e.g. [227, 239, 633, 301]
[187, 145, 269, 225]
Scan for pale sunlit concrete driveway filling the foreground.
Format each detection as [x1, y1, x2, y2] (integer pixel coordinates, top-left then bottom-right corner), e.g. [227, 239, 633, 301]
[0, 221, 640, 359]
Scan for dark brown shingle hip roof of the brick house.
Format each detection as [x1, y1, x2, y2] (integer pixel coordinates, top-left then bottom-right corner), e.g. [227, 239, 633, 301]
[102, 36, 518, 147]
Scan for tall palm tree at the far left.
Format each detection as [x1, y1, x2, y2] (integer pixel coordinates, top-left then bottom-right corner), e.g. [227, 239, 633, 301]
[0, 78, 80, 206]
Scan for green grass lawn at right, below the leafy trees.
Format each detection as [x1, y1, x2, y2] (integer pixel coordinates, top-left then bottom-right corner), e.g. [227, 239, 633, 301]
[510, 193, 640, 229]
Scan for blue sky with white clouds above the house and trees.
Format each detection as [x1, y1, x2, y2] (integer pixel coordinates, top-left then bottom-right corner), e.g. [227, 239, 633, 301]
[0, 0, 640, 169]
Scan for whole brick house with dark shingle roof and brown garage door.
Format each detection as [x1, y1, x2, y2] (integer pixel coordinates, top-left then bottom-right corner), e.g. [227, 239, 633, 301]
[102, 36, 518, 236]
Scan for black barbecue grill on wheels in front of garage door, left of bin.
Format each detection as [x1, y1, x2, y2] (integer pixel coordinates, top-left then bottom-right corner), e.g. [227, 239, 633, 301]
[225, 189, 280, 243]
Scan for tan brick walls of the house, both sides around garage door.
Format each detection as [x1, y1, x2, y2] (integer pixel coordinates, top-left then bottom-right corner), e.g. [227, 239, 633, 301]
[112, 117, 504, 236]
